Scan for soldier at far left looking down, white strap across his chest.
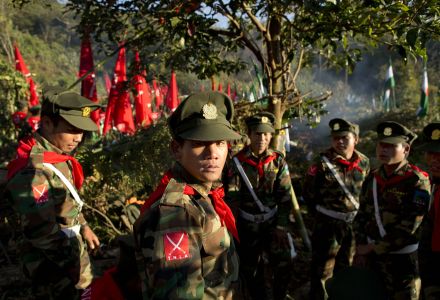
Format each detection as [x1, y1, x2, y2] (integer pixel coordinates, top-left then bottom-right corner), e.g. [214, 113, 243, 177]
[5, 90, 99, 299]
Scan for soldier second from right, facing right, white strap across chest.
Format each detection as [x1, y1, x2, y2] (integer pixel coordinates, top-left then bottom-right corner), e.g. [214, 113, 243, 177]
[356, 122, 430, 299]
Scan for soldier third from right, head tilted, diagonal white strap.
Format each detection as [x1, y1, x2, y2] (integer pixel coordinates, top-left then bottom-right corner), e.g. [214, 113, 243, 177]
[303, 119, 370, 299]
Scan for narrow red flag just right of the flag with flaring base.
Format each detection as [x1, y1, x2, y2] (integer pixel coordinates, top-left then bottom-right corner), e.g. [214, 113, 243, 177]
[132, 51, 152, 126]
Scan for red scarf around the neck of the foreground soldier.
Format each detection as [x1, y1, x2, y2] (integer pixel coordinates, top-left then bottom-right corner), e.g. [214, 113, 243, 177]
[141, 170, 239, 241]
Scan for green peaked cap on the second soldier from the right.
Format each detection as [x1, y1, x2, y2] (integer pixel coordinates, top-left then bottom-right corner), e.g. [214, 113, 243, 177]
[376, 121, 417, 145]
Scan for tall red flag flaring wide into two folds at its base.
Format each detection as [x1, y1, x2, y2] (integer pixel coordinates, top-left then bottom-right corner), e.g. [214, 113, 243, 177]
[103, 47, 135, 134]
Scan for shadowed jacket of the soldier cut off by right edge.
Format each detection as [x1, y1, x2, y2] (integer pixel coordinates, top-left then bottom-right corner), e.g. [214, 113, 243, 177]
[419, 178, 440, 288]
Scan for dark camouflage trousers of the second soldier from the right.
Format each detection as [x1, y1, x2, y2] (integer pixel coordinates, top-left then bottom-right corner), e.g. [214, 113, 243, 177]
[369, 251, 421, 300]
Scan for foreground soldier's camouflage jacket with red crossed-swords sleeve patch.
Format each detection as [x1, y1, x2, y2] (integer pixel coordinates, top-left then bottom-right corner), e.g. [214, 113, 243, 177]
[134, 164, 238, 299]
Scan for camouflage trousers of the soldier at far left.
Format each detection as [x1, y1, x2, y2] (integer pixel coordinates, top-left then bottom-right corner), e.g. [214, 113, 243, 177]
[23, 232, 93, 300]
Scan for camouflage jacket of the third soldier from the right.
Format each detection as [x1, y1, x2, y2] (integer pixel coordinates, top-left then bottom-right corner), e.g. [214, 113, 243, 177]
[302, 148, 370, 213]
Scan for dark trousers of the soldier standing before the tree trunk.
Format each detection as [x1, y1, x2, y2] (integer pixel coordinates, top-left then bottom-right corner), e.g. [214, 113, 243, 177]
[237, 218, 293, 300]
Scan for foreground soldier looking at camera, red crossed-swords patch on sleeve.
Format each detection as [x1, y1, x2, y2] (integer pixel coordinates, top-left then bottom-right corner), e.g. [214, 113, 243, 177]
[134, 92, 240, 299]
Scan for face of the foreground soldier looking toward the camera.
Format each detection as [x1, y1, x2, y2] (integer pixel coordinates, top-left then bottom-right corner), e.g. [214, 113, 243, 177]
[172, 140, 228, 182]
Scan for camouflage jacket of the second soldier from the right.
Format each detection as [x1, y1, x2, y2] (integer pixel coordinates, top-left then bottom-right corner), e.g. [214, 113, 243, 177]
[356, 160, 430, 254]
